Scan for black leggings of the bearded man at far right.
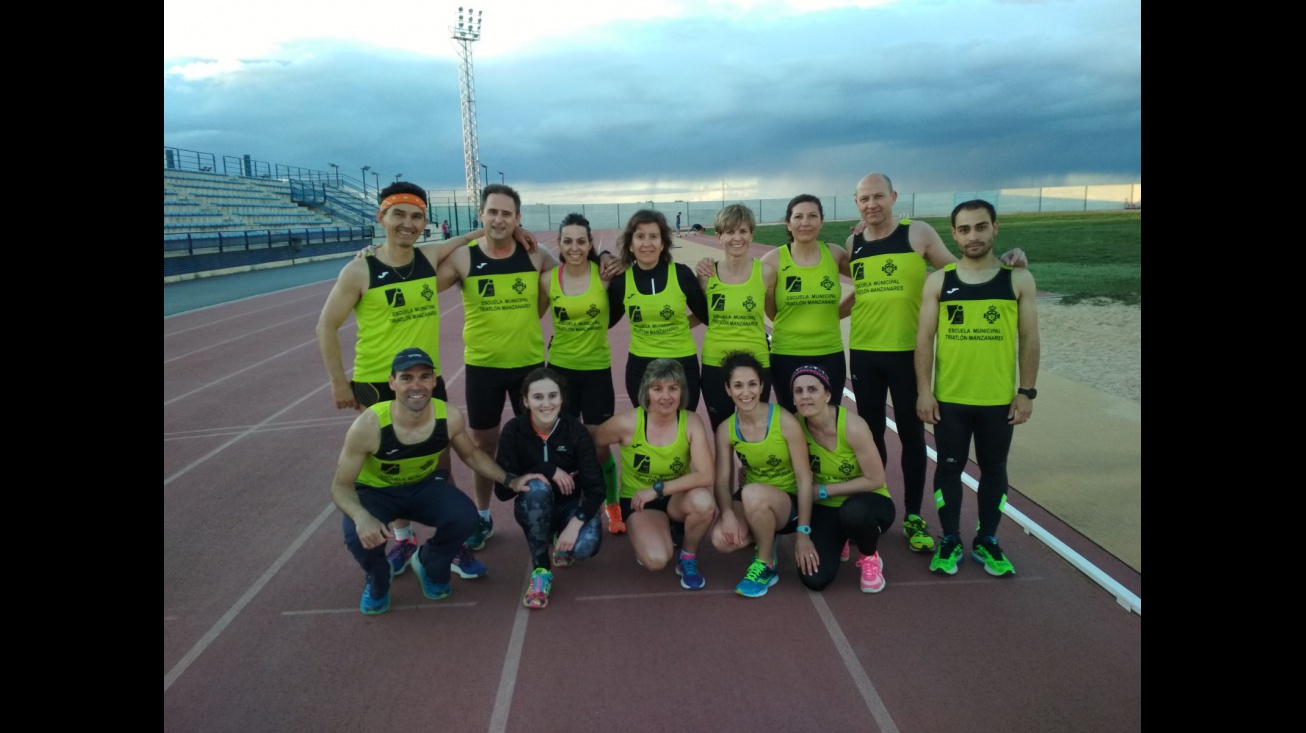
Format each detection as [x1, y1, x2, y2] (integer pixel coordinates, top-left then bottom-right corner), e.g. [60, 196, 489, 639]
[934, 402, 1015, 538]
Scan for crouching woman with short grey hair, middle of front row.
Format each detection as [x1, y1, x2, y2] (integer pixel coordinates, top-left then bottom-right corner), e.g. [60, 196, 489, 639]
[594, 359, 716, 591]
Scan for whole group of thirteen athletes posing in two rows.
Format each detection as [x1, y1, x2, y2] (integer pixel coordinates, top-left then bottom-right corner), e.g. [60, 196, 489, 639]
[317, 174, 1038, 614]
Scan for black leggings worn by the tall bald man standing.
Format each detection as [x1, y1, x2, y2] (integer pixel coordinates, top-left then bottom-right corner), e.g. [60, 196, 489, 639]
[848, 349, 926, 515]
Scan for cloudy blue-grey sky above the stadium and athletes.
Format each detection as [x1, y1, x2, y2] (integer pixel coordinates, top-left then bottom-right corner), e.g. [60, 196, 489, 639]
[163, 0, 1143, 204]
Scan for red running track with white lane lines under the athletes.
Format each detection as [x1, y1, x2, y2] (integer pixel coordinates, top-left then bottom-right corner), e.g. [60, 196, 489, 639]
[163, 231, 1143, 733]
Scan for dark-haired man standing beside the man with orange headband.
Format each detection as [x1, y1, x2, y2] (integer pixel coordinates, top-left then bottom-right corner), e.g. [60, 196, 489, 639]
[439, 183, 558, 550]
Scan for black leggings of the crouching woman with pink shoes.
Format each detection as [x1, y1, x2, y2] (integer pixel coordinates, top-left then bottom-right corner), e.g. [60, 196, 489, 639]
[798, 491, 895, 591]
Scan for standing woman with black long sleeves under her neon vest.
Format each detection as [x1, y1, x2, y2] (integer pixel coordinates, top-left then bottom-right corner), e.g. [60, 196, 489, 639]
[607, 209, 708, 413]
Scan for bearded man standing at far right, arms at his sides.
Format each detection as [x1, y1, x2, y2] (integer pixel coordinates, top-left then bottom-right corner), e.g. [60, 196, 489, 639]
[916, 199, 1040, 576]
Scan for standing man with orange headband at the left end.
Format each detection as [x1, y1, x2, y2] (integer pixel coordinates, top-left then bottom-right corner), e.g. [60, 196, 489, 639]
[317, 180, 533, 578]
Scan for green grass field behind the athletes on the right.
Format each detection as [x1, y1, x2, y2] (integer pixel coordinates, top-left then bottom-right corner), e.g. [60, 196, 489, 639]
[731, 210, 1143, 304]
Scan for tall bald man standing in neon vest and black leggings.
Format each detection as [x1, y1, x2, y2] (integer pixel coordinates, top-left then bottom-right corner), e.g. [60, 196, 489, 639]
[840, 172, 1025, 553]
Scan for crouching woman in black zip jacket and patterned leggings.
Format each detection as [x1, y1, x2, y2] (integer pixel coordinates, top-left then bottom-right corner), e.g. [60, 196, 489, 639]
[495, 367, 603, 609]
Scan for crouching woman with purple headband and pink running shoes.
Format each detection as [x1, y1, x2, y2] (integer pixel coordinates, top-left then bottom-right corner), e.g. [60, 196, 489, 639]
[790, 365, 895, 593]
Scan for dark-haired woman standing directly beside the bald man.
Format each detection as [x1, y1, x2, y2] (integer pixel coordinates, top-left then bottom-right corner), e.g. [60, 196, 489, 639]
[761, 193, 850, 412]
